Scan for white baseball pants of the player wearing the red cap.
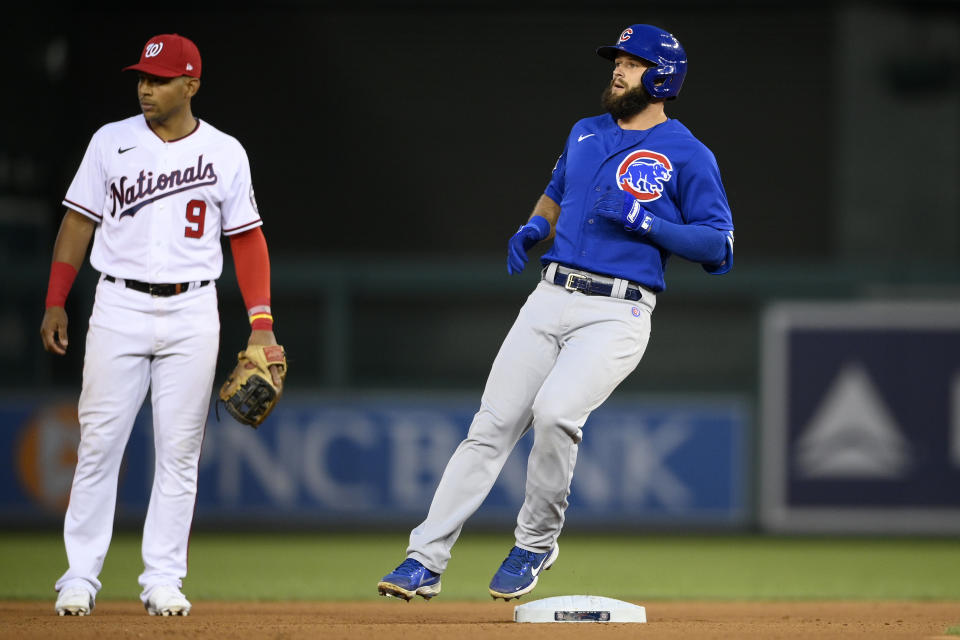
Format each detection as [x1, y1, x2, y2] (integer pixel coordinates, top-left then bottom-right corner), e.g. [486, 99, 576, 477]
[56, 278, 220, 599]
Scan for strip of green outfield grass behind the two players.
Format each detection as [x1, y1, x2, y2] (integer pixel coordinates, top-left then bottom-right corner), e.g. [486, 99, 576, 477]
[0, 532, 960, 604]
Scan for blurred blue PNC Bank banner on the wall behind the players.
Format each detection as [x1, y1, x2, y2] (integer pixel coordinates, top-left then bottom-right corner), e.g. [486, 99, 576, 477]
[0, 394, 750, 527]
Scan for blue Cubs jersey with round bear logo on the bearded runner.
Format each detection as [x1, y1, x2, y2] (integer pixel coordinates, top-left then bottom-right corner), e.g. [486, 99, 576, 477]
[542, 114, 733, 291]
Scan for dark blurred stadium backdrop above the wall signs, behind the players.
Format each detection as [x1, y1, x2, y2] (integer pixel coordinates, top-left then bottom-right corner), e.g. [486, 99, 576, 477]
[0, 1, 960, 398]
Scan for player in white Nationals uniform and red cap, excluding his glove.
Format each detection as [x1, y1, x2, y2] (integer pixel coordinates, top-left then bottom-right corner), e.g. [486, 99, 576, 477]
[40, 34, 281, 615]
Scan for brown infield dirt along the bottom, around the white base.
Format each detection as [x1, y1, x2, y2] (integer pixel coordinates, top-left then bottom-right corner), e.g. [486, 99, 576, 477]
[0, 600, 960, 640]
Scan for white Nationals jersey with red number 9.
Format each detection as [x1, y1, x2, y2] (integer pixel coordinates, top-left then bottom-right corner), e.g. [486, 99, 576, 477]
[63, 115, 262, 283]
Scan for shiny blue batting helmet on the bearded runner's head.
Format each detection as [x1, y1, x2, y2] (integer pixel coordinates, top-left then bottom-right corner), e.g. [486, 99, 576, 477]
[597, 24, 687, 98]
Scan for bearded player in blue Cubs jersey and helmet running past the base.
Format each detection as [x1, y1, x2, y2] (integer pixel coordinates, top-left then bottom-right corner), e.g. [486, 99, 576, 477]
[377, 24, 733, 600]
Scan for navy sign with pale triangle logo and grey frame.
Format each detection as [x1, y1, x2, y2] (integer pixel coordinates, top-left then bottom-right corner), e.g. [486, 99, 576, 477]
[761, 303, 960, 533]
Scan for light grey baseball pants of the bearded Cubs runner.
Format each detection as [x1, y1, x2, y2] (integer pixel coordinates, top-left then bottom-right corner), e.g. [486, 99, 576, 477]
[407, 267, 656, 573]
